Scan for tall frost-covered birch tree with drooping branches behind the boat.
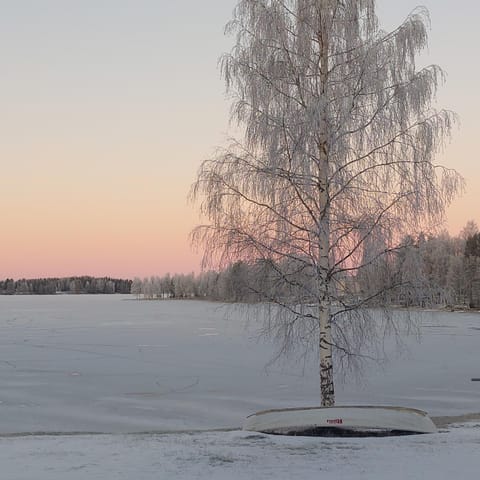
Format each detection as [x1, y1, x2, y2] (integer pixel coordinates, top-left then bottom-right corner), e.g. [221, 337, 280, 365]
[192, 0, 462, 406]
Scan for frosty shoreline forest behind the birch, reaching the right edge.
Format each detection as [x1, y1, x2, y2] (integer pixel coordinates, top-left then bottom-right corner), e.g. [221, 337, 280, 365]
[131, 222, 480, 308]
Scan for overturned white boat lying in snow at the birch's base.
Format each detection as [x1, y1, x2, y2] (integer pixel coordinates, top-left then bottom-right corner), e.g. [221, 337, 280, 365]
[243, 406, 437, 436]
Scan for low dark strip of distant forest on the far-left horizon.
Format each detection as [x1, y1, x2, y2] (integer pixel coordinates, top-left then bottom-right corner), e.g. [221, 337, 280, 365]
[0, 276, 132, 295]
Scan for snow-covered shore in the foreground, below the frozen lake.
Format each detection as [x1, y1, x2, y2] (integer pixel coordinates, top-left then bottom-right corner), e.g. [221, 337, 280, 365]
[0, 424, 480, 480]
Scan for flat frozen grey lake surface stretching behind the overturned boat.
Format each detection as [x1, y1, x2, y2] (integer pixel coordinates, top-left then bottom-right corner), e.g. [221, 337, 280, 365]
[0, 295, 480, 433]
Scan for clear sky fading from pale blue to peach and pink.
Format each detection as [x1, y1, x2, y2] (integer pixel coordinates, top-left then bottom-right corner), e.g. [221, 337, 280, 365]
[0, 0, 480, 278]
